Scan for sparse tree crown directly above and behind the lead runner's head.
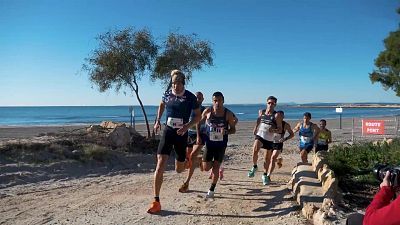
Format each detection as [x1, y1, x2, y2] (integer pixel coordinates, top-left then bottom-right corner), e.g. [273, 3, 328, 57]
[151, 32, 214, 90]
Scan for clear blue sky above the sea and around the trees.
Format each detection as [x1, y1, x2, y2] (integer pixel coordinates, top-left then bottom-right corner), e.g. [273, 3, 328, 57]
[0, 0, 400, 106]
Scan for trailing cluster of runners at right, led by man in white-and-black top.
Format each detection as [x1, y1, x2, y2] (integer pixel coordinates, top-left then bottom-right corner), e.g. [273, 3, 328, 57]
[248, 96, 332, 185]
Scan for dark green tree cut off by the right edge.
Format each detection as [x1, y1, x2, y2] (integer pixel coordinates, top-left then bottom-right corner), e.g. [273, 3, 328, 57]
[369, 8, 400, 97]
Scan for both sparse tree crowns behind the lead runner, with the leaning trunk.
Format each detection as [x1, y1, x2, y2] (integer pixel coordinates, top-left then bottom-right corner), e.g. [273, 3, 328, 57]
[83, 28, 213, 136]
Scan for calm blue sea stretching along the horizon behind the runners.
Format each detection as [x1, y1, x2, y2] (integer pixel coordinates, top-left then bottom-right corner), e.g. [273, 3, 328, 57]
[0, 104, 400, 127]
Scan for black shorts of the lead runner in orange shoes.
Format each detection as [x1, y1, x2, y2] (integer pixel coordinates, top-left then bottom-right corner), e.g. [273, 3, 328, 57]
[157, 126, 188, 162]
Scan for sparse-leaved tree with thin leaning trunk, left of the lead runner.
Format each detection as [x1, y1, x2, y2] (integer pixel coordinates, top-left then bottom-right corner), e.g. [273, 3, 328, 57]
[83, 28, 158, 137]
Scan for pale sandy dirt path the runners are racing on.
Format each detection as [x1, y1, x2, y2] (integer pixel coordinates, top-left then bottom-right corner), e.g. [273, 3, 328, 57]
[0, 144, 307, 224]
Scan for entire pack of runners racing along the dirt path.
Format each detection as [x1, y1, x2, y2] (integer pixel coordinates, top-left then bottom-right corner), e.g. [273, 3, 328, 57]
[147, 70, 331, 214]
